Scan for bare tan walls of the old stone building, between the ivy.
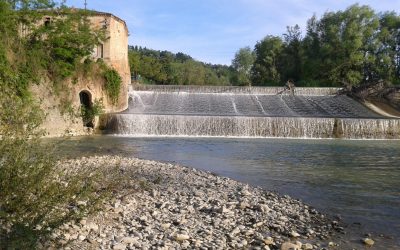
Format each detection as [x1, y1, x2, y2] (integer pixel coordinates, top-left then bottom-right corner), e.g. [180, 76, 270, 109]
[32, 11, 131, 136]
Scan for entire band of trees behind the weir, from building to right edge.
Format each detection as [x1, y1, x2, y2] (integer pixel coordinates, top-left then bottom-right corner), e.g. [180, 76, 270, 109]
[135, 4, 400, 87]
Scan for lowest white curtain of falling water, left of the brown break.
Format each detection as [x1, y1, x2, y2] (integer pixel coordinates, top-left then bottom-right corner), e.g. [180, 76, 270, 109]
[102, 114, 335, 138]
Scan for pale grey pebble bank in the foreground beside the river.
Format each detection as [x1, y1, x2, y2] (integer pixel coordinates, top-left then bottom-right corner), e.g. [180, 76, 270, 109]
[49, 156, 350, 249]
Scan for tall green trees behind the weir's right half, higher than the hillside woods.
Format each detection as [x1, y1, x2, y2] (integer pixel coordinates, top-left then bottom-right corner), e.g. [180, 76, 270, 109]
[233, 5, 400, 87]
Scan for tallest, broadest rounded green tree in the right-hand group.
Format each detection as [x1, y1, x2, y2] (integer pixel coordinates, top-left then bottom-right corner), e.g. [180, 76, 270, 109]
[305, 5, 379, 87]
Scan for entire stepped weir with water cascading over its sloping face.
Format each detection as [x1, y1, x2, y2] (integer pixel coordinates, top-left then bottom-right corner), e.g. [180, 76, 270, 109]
[102, 85, 400, 139]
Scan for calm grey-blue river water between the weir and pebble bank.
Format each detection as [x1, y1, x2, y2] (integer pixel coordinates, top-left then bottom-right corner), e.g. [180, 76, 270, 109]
[56, 136, 400, 249]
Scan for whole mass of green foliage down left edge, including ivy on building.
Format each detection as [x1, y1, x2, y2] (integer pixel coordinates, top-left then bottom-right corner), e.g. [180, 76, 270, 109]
[0, 3, 119, 246]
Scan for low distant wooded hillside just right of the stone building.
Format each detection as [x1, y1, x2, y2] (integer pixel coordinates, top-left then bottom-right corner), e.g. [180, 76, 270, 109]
[129, 46, 235, 85]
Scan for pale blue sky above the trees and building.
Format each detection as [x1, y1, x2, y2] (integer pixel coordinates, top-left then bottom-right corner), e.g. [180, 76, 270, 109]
[67, 0, 400, 65]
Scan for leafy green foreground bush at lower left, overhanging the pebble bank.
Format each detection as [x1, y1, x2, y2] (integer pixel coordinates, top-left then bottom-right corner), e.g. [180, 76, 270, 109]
[0, 87, 120, 249]
